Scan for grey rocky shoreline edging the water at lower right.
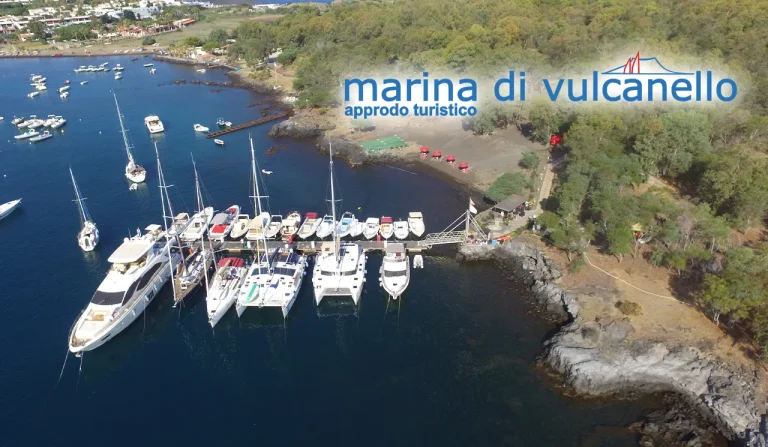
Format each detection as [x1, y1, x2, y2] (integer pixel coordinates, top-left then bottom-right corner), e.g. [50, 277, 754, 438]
[458, 241, 766, 445]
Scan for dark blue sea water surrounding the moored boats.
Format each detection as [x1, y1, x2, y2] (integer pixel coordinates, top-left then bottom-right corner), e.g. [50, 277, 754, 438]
[0, 57, 648, 446]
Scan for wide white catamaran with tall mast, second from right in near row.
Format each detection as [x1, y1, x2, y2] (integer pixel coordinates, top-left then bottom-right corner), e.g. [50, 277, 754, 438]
[312, 146, 366, 305]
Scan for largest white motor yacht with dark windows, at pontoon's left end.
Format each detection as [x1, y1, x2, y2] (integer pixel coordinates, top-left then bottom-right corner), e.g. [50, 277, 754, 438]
[69, 225, 181, 353]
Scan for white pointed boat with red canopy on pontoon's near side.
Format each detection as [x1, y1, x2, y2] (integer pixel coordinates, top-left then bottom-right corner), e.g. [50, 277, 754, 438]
[205, 257, 246, 327]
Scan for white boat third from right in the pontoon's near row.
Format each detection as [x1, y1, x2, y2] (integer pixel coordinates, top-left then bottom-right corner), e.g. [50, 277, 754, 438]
[258, 247, 307, 318]
